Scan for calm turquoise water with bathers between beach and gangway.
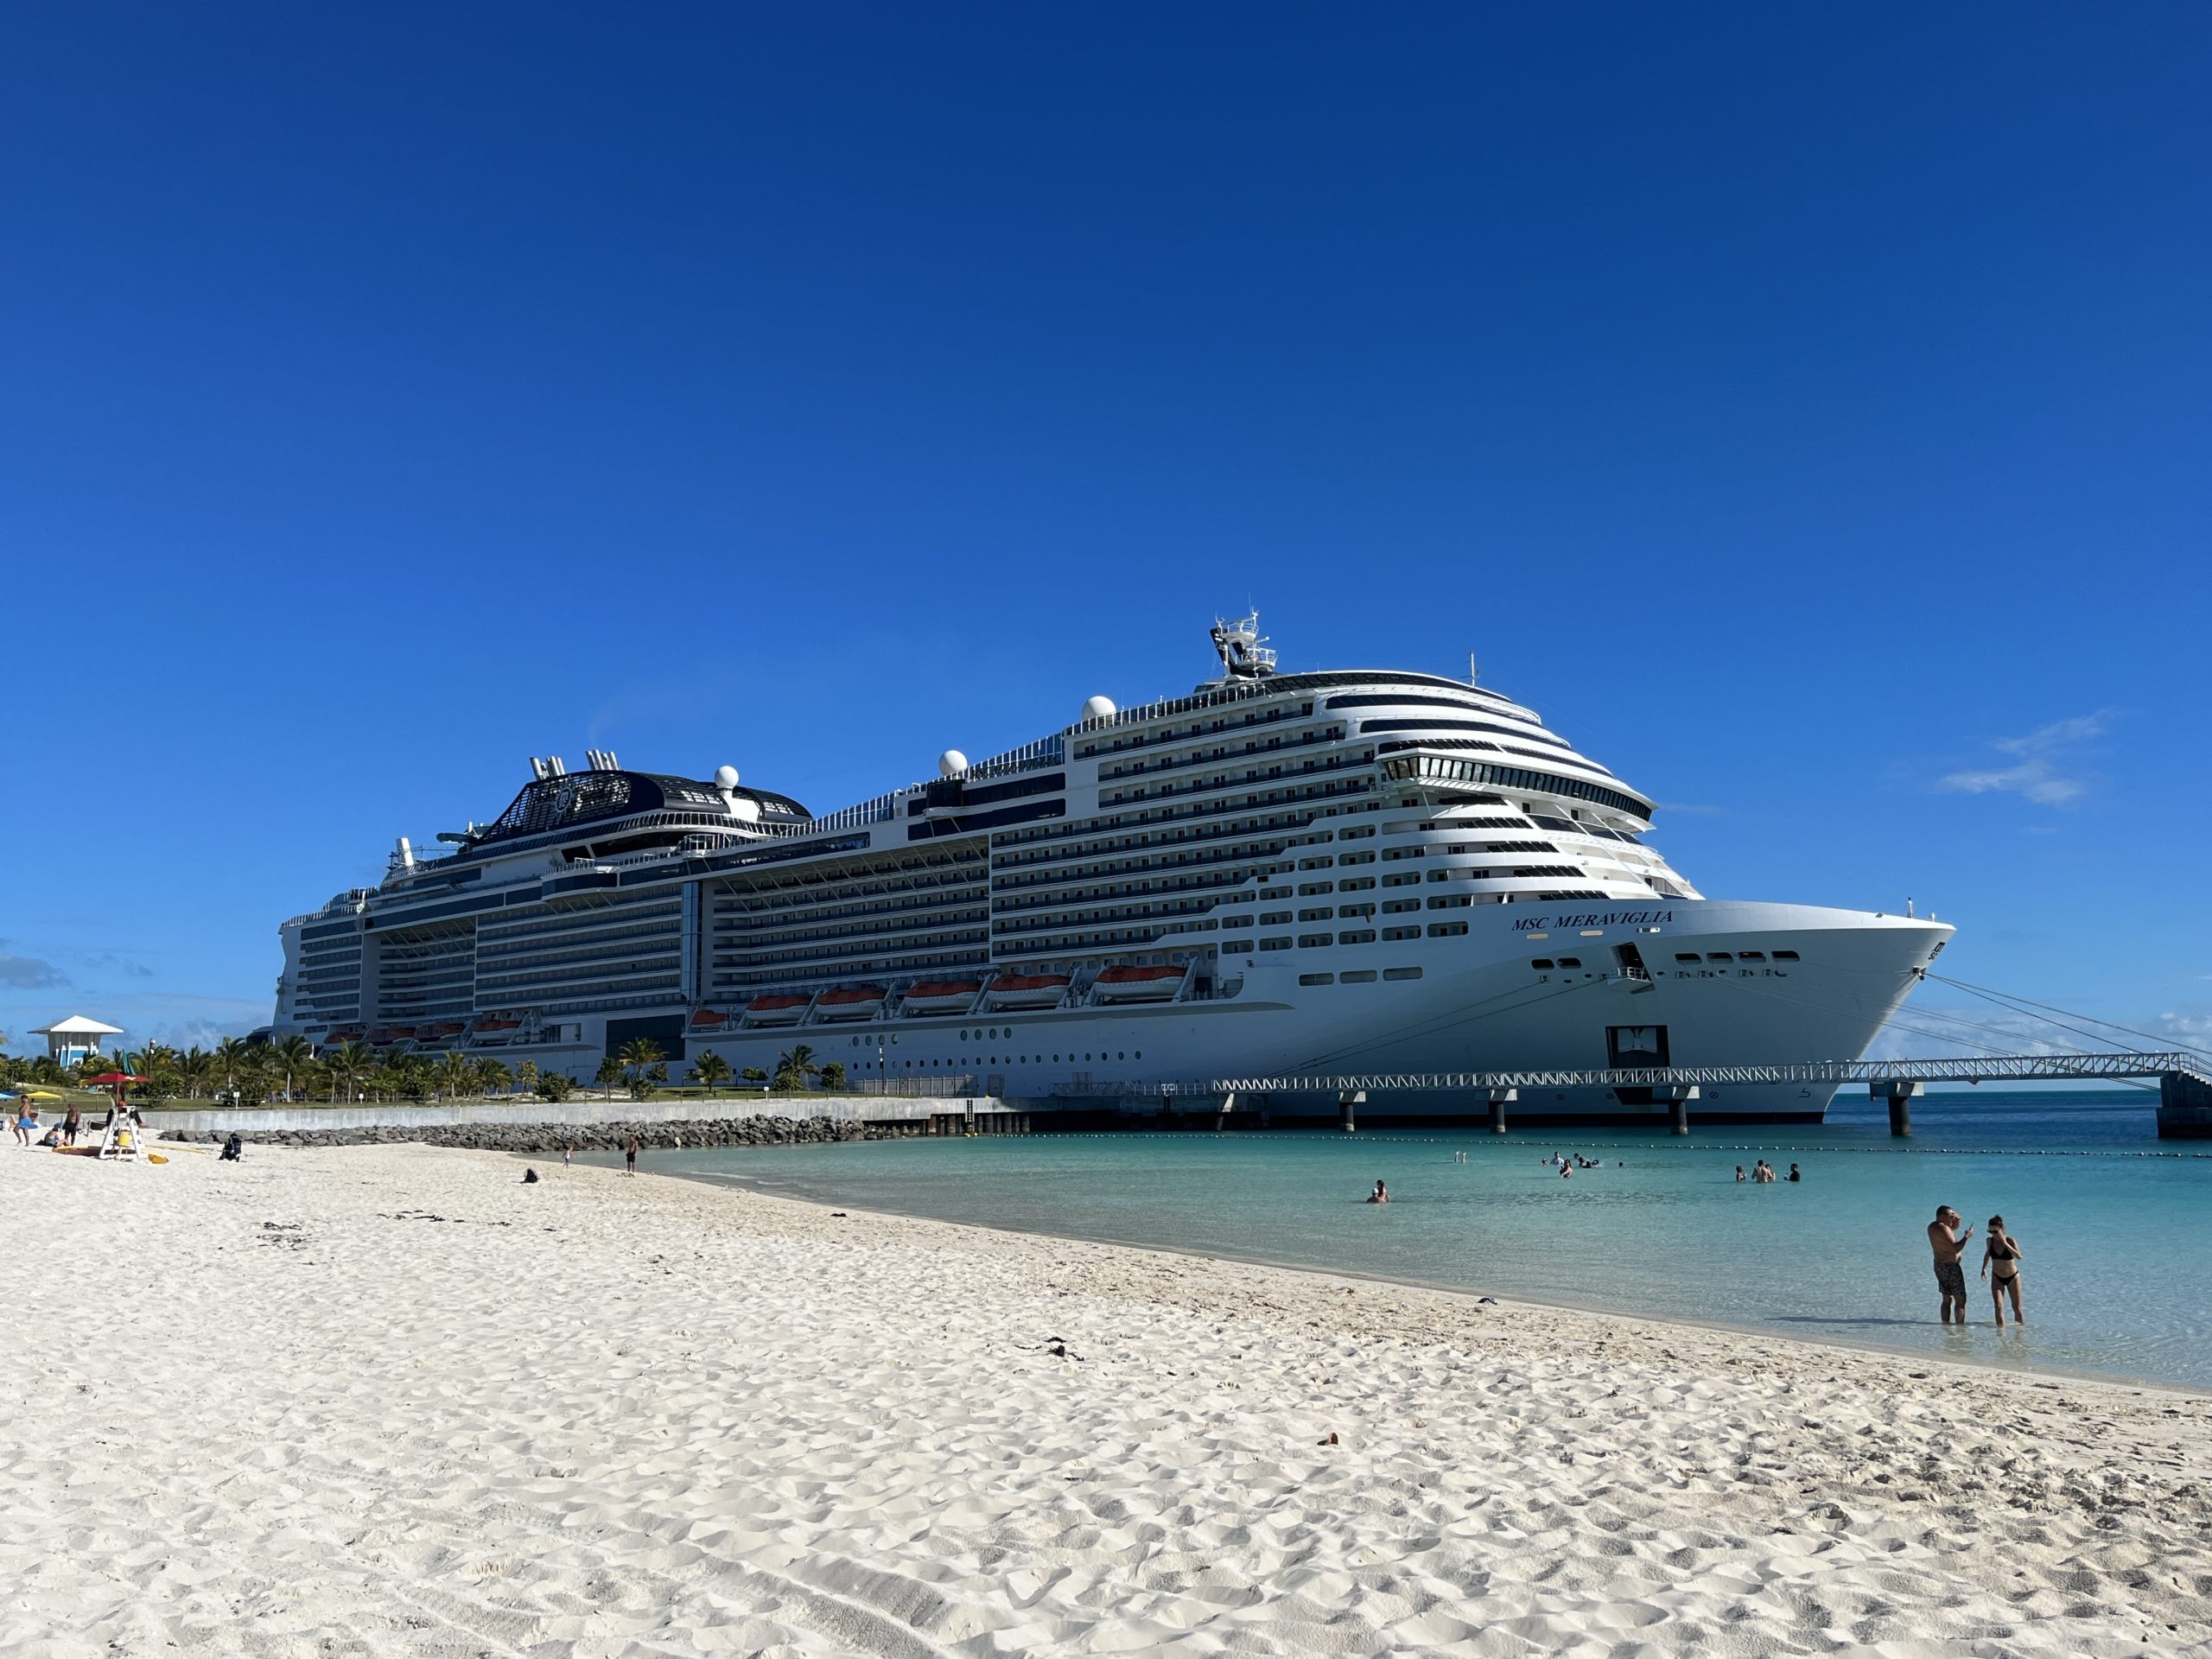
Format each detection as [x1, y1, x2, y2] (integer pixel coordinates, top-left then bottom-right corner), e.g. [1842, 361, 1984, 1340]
[601, 1090, 2212, 1387]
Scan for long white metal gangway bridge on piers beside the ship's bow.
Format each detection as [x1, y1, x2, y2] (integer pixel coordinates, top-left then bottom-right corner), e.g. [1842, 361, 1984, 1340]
[1164, 1053, 2212, 1139]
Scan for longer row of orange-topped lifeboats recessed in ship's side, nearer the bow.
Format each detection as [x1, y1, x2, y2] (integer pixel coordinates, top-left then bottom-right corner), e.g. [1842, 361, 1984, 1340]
[688, 957, 1214, 1042]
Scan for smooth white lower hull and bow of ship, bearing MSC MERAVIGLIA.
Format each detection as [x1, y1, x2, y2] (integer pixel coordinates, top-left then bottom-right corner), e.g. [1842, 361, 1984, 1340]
[692, 900, 1951, 1126]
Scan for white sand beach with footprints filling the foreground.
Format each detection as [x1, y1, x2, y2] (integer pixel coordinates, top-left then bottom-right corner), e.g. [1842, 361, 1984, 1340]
[0, 1146, 2212, 1659]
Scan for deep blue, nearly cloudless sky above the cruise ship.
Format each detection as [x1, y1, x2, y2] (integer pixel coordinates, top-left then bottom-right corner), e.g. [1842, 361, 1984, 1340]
[0, 4, 2212, 1048]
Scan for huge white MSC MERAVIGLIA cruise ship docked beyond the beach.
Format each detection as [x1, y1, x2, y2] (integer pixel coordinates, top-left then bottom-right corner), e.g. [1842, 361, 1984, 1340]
[274, 615, 1951, 1123]
